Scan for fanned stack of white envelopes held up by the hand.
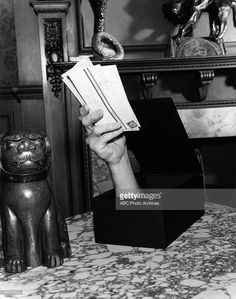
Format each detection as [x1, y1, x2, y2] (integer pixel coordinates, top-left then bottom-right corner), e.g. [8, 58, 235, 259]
[62, 58, 140, 131]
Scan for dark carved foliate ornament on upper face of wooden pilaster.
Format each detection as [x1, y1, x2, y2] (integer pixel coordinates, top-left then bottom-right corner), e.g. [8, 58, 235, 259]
[43, 18, 64, 97]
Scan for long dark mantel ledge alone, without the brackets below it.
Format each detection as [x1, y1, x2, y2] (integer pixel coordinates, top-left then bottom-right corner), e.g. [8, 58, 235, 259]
[54, 55, 236, 73]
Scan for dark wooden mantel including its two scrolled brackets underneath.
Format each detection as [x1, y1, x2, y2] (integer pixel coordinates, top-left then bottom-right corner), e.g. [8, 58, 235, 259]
[53, 55, 236, 106]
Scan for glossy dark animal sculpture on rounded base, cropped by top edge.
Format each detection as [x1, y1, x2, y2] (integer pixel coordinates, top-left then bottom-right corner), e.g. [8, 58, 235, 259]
[163, 0, 236, 42]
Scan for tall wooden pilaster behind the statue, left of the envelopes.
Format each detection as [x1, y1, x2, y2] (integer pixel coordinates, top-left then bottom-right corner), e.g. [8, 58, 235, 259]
[29, 1, 91, 216]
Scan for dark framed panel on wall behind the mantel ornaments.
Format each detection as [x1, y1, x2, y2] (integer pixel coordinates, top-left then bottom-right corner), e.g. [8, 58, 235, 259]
[76, 0, 236, 59]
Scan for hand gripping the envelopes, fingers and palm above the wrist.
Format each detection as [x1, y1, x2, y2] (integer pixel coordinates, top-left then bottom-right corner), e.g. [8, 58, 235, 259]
[79, 106, 126, 166]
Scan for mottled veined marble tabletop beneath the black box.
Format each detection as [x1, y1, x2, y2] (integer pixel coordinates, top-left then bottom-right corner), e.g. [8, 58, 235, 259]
[0, 203, 236, 299]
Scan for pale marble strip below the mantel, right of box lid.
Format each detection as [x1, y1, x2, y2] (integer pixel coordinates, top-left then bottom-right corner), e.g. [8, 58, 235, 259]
[178, 107, 236, 138]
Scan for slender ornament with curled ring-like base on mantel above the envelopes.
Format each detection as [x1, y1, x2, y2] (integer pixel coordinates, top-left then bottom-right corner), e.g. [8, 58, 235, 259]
[89, 0, 124, 60]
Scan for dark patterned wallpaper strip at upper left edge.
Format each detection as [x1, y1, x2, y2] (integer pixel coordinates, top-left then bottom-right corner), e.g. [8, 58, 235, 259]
[0, 0, 18, 87]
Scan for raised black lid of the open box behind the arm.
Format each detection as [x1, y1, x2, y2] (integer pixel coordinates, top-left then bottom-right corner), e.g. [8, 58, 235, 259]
[126, 98, 202, 178]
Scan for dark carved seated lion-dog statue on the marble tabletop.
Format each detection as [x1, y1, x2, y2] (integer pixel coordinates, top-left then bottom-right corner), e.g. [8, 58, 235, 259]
[0, 130, 71, 273]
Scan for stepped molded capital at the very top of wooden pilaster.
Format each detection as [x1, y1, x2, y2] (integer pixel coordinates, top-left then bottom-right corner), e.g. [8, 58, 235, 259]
[30, 1, 71, 14]
